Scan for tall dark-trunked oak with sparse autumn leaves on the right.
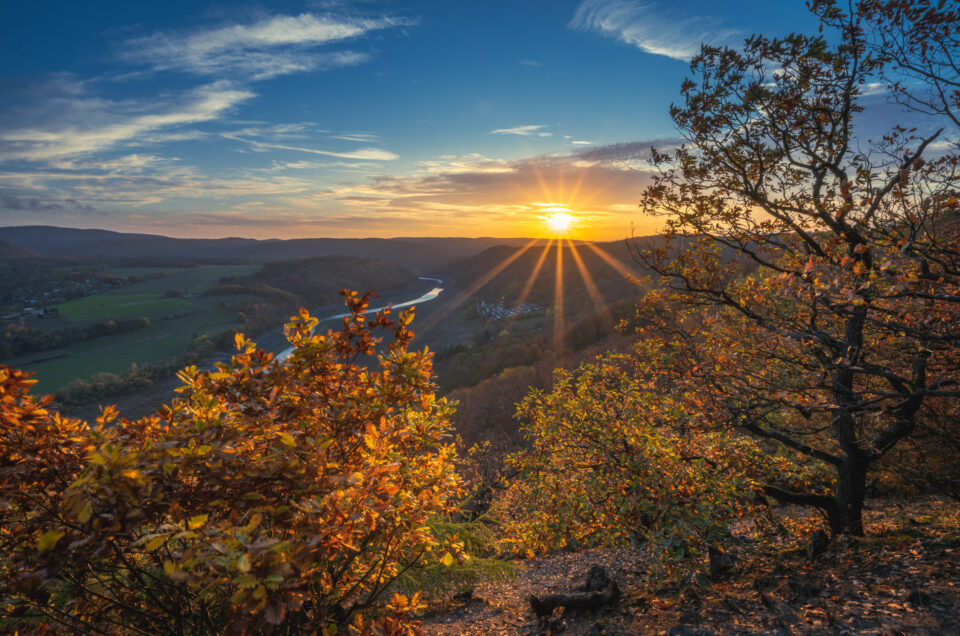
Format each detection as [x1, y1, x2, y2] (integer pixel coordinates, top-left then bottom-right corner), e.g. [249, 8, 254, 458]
[636, 0, 960, 534]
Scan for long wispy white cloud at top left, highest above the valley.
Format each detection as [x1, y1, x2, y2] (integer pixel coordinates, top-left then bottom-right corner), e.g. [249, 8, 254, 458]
[124, 13, 410, 80]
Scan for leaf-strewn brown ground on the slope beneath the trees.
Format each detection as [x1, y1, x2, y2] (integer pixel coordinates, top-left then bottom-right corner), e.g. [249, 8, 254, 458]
[423, 498, 960, 636]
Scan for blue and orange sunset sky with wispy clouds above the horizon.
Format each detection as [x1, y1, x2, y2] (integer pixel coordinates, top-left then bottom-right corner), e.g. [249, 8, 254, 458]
[0, 0, 817, 240]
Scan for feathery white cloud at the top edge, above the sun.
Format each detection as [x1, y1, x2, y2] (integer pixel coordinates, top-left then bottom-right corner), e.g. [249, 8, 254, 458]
[570, 0, 737, 61]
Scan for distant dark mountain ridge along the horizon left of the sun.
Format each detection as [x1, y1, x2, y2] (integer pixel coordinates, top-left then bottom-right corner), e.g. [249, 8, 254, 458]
[0, 225, 548, 272]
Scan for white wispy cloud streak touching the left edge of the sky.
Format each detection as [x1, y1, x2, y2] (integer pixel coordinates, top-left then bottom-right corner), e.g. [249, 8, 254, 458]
[0, 81, 253, 162]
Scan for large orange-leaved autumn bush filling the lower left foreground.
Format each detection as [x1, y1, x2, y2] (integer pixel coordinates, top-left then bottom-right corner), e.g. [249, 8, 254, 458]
[0, 293, 461, 634]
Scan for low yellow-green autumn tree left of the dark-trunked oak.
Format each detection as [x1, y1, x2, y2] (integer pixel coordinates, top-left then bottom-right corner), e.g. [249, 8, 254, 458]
[493, 346, 796, 577]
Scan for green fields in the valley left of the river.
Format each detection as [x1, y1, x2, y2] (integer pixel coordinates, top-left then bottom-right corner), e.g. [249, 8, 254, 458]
[5, 265, 259, 393]
